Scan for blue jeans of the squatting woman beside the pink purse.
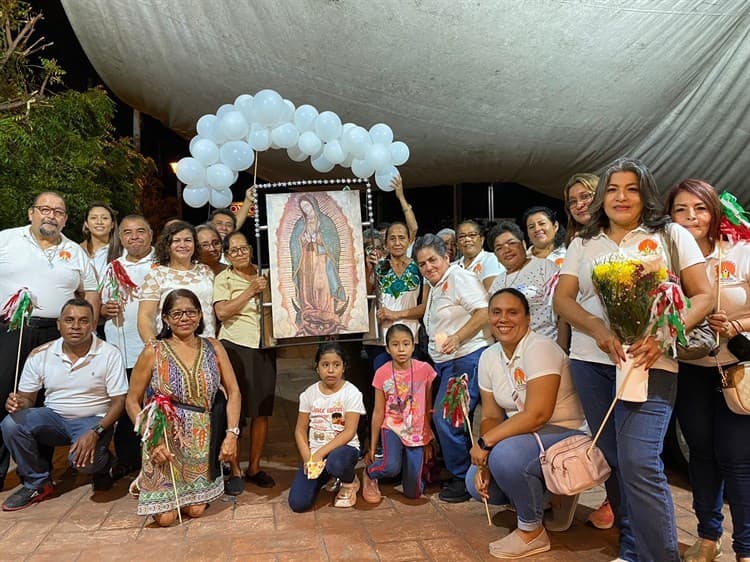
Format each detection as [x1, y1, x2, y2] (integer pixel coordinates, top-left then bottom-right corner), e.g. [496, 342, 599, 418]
[466, 427, 583, 531]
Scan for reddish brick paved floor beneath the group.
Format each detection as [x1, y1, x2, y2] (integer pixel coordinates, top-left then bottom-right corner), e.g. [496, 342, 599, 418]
[0, 359, 733, 562]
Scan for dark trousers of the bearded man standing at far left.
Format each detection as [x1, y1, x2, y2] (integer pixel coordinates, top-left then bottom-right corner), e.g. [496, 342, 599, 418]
[0, 322, 60, 488]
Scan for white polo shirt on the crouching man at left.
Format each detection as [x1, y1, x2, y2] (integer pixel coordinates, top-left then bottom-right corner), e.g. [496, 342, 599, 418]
[18, 334, 128, 419]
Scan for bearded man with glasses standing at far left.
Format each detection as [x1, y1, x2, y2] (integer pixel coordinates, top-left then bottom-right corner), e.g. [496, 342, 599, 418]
[0, 191, 99, 486]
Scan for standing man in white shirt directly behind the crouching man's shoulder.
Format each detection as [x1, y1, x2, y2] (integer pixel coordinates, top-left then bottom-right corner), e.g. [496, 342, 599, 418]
[102, 215, 154, 480]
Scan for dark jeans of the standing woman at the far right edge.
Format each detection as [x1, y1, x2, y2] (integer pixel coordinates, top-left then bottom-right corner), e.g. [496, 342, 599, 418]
[675, 363, 750, 556]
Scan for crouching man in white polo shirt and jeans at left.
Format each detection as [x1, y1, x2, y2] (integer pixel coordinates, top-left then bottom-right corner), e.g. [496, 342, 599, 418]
[0, 298, 128, 511]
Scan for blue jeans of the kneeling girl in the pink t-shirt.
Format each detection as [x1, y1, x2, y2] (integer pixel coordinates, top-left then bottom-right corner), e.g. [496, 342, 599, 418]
[366, 428, 424, 499]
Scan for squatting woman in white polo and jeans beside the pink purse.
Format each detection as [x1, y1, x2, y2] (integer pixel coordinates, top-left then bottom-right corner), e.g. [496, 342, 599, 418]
[466, 288, 584, 558]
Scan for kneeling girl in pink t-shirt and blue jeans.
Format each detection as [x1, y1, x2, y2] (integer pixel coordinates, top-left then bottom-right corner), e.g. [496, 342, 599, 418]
[362, 324, 435, 503]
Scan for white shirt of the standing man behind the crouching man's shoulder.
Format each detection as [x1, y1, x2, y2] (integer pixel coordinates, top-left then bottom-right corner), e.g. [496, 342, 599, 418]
[102, 248, 154, 369]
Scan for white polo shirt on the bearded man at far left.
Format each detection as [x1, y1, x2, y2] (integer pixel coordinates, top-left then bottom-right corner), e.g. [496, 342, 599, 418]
[0, 225, 97, 318]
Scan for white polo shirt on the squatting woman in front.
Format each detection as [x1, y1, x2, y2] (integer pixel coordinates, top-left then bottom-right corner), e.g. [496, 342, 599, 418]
[478, 330, 584, 433]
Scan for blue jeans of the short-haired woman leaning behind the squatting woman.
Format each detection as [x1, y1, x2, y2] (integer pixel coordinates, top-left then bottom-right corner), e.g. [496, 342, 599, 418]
[432, 347, 486, 480]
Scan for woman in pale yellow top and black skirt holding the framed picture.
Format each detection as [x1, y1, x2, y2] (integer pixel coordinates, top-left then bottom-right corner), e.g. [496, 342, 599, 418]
[213, 232, 276, 495]
